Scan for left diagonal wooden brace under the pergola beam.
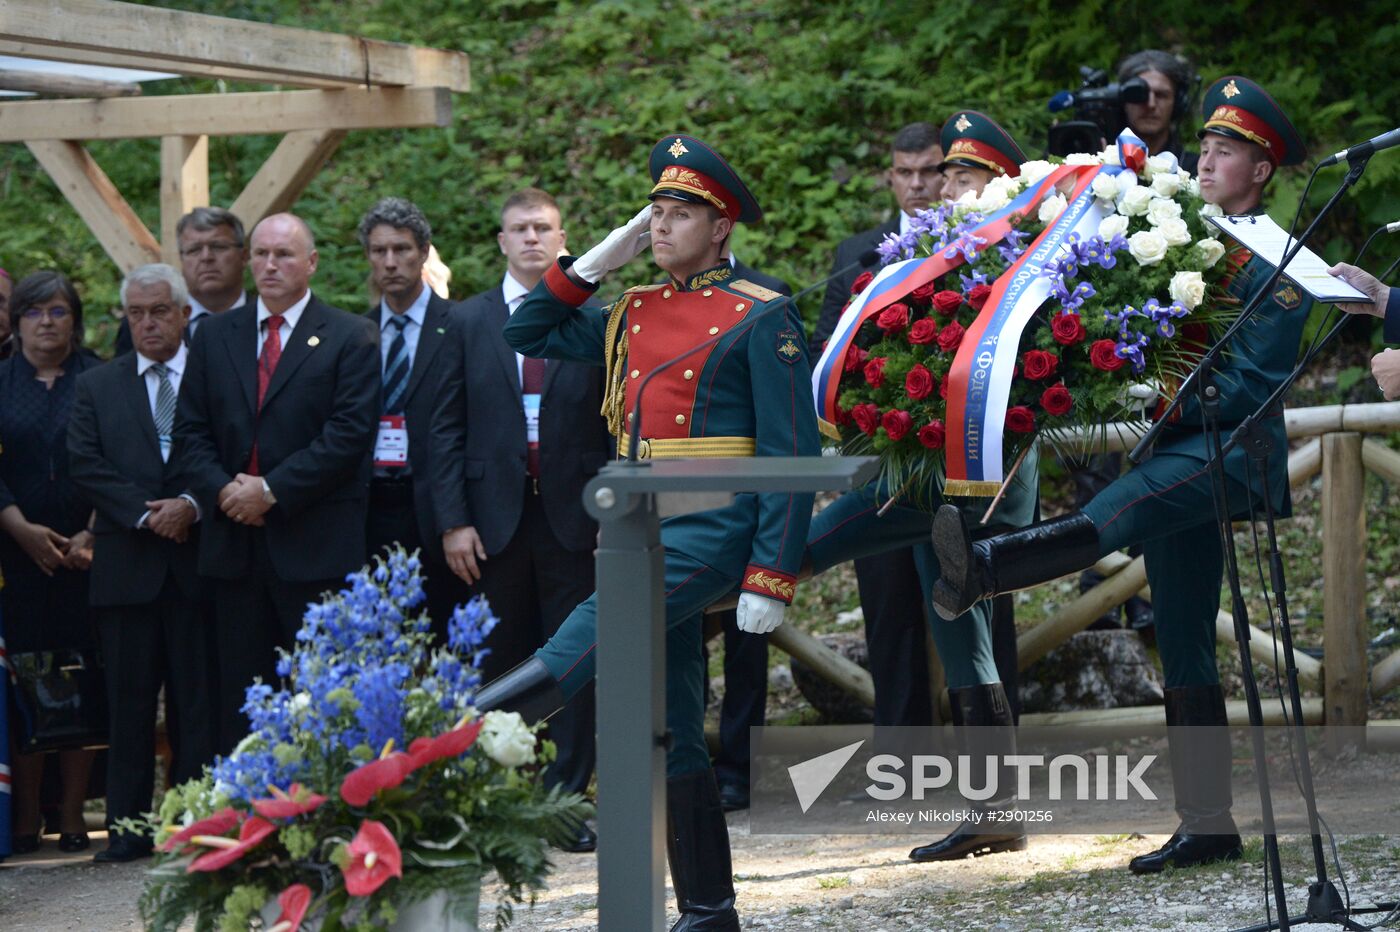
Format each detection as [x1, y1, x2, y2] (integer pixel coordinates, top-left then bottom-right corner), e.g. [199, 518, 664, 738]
[29, 140, 161, 271]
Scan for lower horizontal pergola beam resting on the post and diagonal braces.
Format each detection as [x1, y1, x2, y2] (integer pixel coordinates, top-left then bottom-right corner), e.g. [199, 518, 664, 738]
[0, 87, 452, 143]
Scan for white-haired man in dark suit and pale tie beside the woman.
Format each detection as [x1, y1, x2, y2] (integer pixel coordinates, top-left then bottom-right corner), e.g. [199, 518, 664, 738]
[69, 258, 214, 862]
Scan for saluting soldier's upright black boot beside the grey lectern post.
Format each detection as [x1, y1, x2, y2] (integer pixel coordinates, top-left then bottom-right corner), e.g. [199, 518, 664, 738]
[666, 770, 739, 932]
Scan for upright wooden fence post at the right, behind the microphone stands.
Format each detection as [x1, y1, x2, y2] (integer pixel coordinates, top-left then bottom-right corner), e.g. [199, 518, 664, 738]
[1322, 434, 1368, 753]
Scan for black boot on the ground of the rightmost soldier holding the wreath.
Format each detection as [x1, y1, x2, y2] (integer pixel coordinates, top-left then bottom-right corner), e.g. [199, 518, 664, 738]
[1128, 686, 1245, 873]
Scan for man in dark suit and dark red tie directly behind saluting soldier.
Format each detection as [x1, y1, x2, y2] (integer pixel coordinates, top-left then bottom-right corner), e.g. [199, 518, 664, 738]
[430, 188, 612, 851]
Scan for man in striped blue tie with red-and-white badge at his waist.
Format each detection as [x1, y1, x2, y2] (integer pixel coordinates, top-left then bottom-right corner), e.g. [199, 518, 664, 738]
[358, 197, 470, 632]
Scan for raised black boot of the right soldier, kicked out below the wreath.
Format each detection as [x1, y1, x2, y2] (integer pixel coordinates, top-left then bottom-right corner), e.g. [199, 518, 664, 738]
[934, 505, 1099, 621]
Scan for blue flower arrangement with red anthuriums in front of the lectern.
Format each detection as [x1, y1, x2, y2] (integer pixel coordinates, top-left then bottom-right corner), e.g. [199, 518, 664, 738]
[137, 549, 591, 932]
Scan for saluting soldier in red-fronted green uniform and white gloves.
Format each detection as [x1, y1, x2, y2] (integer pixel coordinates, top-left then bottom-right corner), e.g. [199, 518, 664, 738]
[477, 136, 820, 931]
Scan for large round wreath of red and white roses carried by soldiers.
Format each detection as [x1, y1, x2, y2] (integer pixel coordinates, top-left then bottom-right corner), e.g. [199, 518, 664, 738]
[819, 147, 1239, 500]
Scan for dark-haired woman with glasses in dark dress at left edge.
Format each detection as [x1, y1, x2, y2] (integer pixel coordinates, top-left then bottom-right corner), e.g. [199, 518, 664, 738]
[0, 271, 101, 855]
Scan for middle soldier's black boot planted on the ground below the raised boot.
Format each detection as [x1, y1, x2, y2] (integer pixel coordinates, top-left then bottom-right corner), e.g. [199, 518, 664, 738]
[909, 683, 1026, 861]
